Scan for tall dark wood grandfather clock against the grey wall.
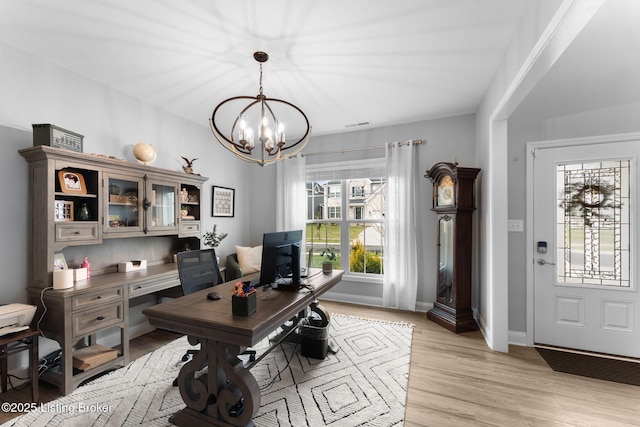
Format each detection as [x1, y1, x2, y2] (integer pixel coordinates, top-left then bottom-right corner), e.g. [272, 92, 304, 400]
[425, 162, 480, 333]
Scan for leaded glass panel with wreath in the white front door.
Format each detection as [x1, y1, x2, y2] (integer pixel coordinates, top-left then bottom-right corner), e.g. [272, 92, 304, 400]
[557, 160, 631, 288]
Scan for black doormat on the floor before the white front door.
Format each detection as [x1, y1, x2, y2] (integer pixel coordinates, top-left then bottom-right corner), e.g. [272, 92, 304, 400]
[536, 346, 640, 386]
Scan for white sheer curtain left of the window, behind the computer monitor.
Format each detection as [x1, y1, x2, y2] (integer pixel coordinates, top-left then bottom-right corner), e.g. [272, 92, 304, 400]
[276, 155, 307, 267]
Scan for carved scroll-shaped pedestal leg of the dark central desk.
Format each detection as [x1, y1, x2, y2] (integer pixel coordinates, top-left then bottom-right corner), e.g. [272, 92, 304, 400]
[170, 336, 260, 426]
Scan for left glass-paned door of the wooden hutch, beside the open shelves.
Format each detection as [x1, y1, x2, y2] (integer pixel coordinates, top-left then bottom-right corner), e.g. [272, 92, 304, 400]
[103, 174, 144, 233]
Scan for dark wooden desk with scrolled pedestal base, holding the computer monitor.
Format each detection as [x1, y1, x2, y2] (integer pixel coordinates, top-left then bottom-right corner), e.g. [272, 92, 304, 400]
[143, 269, 344, 426]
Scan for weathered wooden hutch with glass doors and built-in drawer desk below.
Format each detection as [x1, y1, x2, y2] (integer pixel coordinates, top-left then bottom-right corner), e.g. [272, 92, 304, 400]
[20, 145, 207, 394]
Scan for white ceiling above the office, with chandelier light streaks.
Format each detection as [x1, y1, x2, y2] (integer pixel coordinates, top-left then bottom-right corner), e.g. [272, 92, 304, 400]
[0, 0, 527, 134]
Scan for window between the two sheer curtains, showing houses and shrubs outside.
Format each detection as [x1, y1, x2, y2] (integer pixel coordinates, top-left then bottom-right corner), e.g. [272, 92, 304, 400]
[306, 162, 386, 276]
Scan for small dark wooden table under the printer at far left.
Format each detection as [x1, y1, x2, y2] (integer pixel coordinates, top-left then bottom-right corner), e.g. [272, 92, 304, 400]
[0, 329, 40, 403]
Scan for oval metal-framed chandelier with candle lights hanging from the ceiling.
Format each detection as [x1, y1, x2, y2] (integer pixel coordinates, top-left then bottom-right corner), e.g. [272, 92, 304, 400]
[209, 52, 311, 166]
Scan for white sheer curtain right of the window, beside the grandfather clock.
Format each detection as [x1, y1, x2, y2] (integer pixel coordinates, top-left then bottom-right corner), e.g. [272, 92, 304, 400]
[382, 141, 418, 311]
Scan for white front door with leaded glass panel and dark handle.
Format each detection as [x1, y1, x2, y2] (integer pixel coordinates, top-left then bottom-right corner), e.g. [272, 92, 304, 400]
[532, 141, 640, 357]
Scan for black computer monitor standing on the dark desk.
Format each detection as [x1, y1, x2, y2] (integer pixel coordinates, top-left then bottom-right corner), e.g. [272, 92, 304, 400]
[260, 230, 302, 289]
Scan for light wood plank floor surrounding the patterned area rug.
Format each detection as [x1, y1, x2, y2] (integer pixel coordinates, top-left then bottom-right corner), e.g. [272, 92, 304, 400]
[0, 301, 640, 427]
